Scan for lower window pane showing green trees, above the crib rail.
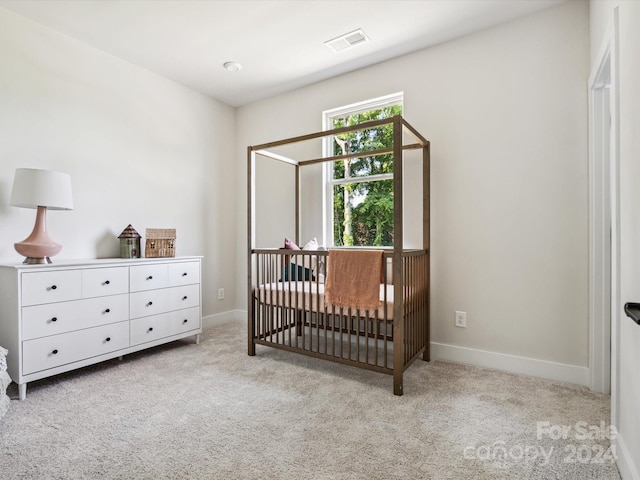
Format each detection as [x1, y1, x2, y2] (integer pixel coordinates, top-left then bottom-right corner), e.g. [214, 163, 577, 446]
[333, 180, 393, 246]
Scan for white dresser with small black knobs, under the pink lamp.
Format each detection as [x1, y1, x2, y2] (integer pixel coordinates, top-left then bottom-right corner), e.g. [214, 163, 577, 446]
[0, 257, 202, 400]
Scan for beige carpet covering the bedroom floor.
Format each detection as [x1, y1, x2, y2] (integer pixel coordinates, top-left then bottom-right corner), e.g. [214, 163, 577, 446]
[0, 322, 619, 480]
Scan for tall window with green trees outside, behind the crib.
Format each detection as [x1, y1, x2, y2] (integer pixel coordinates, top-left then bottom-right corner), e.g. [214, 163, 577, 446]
[324, 93, 402, 246]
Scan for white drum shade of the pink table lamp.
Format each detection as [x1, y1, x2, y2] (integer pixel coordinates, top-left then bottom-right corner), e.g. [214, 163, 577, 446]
[9, 168, 73, 210]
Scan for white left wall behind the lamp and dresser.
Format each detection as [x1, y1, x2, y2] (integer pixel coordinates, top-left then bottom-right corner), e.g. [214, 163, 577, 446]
[0, 8, 235, 315]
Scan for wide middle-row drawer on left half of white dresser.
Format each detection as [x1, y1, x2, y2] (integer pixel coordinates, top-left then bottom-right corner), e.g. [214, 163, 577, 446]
[22, 294, 129, 340]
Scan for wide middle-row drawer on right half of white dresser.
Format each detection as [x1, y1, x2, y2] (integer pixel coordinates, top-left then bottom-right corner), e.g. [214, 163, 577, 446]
[129, 284, 200, 318]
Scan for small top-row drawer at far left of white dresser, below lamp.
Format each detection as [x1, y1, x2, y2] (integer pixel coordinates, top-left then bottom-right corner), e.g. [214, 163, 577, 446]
[22, 270, 82, 305]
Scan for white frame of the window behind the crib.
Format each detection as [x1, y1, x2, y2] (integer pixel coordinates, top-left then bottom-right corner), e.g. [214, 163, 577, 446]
[322, 92, 405, 246]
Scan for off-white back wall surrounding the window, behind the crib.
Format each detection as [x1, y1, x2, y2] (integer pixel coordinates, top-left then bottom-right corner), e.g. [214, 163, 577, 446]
[238, 2, 589, 376]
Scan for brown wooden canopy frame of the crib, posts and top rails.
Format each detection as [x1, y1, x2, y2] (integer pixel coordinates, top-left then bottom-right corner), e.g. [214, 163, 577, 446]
[247, 115, 430, 395]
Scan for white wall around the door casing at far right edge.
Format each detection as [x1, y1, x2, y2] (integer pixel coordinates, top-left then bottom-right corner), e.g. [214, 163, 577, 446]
[590, 1, 640, 480]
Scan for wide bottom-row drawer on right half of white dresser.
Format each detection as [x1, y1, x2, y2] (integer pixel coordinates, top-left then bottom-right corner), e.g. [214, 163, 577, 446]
[130, 307, 200, 346]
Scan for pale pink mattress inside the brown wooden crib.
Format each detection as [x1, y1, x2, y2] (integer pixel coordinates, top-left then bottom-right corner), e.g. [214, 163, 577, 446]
[254, 281, 393, 320]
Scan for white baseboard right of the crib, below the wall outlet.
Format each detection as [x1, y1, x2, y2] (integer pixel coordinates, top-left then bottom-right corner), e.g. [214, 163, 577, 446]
[431, 342, 589, 387]
